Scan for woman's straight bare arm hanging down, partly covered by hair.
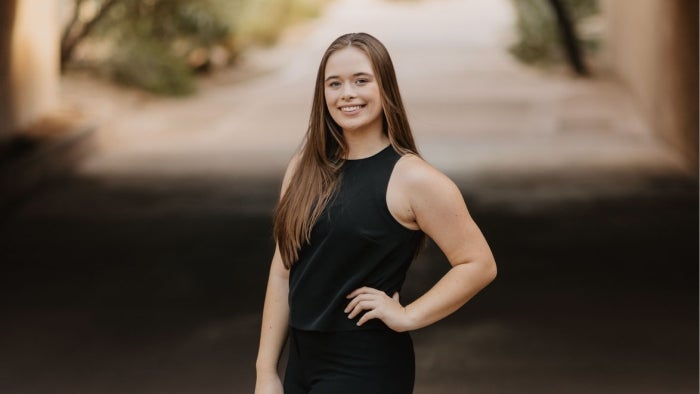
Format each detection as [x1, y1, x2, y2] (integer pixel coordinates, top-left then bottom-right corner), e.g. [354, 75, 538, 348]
[255, 156, 299, 394]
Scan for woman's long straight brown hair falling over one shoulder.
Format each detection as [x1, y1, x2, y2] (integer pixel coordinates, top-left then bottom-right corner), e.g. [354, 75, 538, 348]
[274, 33, 418, 268]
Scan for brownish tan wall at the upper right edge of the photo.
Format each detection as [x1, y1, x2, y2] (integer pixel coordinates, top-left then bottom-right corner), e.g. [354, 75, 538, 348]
[601, 0, 699, 172]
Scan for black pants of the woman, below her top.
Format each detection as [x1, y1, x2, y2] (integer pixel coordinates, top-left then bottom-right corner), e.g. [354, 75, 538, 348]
[284, 327, 415, 394]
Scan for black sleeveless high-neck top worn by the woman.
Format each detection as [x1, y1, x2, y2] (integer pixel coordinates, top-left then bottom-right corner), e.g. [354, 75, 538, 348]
[289, 145, 422, 331]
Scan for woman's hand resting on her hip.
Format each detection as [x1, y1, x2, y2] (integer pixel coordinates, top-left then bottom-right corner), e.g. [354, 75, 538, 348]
[345, 287, 411, 332]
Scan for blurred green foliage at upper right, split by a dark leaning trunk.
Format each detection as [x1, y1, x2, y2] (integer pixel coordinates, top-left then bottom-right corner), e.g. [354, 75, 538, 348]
[509, 0, 600, 65]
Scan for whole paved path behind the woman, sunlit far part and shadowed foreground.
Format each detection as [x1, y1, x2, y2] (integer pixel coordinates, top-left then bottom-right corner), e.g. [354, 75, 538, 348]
[0, 0, 698, 394]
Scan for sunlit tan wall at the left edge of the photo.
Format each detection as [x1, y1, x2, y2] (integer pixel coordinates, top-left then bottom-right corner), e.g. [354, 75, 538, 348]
[0, 0, 60, 141]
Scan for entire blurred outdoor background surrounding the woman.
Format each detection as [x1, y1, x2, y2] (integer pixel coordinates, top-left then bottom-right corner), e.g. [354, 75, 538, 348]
[0, 0, 699, 394]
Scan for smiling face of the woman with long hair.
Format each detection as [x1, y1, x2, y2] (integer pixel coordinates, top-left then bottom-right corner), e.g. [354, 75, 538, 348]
[324, 47, 382, 133]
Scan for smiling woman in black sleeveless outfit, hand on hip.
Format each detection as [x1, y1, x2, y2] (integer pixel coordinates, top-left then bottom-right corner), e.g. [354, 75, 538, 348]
[255, 33, 496, 394]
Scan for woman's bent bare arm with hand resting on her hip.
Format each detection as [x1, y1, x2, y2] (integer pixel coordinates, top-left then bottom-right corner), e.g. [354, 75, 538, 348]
[346, 157, 496, 331]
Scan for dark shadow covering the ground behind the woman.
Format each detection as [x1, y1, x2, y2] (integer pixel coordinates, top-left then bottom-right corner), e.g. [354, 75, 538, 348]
[0, 170, 698, 393]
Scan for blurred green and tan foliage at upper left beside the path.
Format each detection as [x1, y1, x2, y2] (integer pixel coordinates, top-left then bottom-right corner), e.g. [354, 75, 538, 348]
[62, 0, 326, 95]
